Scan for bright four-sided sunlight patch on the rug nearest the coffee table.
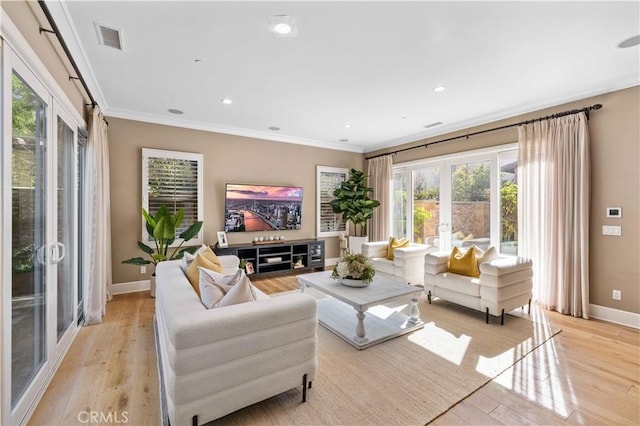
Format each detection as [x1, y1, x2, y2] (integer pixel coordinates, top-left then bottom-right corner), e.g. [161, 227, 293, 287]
[409, 322, 471, 365]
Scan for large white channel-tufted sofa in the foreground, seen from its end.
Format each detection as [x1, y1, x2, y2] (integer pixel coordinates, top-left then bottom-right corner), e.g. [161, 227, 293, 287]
[155, 256, 317, 425]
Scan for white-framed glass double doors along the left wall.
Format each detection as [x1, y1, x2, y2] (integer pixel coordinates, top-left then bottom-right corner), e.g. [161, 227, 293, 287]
[0, 47, 80, 424]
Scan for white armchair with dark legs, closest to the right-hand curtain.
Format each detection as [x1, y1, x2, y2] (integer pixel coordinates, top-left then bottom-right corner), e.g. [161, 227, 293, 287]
[424, 251, 533, 324]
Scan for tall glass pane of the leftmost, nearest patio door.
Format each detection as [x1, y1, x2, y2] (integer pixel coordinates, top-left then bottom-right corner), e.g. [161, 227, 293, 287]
[5, 72, 49, 408]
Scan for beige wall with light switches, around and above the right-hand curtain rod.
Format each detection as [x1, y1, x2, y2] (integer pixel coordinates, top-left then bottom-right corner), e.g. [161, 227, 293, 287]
[368, 86, 640, 313]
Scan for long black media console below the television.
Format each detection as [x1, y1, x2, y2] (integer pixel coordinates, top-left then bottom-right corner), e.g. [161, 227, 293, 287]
[212, 239, 324, 275]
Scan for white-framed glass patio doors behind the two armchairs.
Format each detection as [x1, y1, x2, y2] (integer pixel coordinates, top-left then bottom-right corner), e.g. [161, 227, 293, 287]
[392, 146, 517, 254]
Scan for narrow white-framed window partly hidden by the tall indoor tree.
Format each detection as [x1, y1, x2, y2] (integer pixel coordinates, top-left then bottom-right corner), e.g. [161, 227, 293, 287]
[316, 166, 349, 237]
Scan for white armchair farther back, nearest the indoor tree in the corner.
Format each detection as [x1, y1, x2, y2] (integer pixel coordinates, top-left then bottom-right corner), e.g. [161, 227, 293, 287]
[362, 241, 436, 285]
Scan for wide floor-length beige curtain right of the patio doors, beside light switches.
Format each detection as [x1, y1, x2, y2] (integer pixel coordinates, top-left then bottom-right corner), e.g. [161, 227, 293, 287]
[518, 113, 591, 318]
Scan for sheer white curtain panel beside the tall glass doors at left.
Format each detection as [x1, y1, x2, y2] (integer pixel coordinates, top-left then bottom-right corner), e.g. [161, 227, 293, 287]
[84, 106, 112, 324]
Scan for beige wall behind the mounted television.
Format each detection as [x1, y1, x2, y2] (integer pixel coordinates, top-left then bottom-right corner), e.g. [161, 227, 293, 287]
[108, 117, 363, 283]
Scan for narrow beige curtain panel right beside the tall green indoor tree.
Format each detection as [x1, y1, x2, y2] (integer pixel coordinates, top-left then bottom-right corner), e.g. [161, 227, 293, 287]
[367, 155, 393, 241]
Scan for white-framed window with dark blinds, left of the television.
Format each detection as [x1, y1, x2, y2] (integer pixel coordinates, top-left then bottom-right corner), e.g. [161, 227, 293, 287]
[142, 148, 203, 245]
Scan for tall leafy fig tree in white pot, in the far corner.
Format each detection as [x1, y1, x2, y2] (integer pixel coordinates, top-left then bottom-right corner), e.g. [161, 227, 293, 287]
[331, 169, 380, 253]
